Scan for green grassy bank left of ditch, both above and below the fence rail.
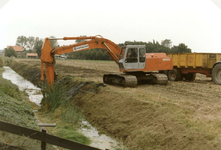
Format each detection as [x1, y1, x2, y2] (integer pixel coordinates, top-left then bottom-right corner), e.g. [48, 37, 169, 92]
[0, 68, 53, 149]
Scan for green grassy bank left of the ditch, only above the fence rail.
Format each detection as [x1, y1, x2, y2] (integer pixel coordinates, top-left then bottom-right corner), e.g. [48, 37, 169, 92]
[0, 68, 39, 129]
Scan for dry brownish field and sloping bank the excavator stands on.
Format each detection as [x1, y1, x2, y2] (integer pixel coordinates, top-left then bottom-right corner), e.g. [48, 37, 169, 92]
[11, 59, 221, 150]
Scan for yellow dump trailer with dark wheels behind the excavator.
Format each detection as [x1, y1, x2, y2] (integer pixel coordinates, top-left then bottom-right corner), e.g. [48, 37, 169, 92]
[165, 53, 221, 84]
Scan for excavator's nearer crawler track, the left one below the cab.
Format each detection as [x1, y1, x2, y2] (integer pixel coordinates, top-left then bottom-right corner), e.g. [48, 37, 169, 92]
[103, 73, 137, 87]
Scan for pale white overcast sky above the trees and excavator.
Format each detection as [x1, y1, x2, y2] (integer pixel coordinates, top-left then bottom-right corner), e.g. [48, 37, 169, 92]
[0, 0, 221, 53]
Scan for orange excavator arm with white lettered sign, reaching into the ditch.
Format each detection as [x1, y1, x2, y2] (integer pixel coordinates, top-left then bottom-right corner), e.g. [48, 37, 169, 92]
[41, 36, 121, 85]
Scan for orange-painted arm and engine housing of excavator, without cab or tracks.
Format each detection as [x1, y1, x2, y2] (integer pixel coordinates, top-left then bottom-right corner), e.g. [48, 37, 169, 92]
[41, 36, 173, 85]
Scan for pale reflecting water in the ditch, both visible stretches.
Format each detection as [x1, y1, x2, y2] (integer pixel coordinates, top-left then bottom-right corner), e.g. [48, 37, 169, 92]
[2, 66, 125, 150]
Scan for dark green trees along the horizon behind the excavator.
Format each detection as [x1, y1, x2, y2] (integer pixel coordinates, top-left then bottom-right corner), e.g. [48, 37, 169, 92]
[5, 36, 192, 60]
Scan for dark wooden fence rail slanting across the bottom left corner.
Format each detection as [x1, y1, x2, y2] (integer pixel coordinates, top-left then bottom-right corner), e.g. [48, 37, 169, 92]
[0, 121, 99, 150]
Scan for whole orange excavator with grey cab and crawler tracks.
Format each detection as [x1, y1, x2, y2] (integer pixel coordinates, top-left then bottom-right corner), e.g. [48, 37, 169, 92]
[41, 35, 173, 87]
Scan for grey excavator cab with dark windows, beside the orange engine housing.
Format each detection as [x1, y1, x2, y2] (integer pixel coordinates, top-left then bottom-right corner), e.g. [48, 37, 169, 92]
[118, 45, 146, 70]
